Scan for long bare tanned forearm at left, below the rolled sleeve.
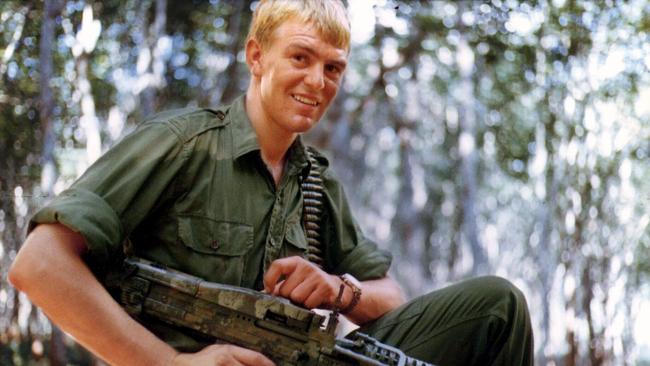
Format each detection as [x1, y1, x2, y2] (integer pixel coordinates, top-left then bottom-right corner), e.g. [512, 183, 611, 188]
[10, 225, 176, 365]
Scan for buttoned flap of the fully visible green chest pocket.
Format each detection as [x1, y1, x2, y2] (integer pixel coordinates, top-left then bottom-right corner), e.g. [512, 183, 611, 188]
[178, 215, 253, 256]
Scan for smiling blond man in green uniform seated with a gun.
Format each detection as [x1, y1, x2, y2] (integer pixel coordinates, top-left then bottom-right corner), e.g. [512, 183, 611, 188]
[10, 0, 532, 365]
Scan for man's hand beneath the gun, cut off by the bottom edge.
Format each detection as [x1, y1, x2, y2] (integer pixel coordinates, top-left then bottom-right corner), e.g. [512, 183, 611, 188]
[172, 344, 275, 366]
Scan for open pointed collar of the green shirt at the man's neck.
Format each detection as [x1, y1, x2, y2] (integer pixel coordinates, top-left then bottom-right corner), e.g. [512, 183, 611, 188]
[228, 94, 311, 174]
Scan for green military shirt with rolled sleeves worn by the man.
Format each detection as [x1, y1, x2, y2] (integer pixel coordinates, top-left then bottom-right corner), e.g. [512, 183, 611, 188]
[30, 96, 391, 350]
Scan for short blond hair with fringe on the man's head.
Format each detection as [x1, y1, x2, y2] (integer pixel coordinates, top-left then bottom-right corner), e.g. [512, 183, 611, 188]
[247, 0, 350, 50]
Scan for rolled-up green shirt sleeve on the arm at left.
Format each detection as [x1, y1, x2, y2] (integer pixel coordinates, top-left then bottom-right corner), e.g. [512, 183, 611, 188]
[28, 122, 189, 272]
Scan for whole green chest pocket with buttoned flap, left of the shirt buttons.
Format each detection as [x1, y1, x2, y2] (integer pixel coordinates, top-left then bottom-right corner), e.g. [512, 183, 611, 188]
[177, 215, 253, 286]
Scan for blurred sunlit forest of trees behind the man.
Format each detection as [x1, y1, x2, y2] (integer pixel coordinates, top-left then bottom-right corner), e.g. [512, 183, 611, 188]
[0, 0, 650, 366]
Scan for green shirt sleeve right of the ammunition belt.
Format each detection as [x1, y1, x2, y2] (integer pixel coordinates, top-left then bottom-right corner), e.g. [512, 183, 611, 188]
[324, 173, 392, 280]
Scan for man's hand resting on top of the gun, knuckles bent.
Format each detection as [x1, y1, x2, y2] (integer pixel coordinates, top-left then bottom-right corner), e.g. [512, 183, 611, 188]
[264, 256, 350, 309]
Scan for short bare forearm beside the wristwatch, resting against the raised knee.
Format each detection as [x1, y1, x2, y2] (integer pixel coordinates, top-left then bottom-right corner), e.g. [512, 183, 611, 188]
[343, 277, 406, 325]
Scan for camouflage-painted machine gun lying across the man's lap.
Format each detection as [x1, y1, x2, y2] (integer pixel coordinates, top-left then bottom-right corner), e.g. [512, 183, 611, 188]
[107, 258, 433, 366]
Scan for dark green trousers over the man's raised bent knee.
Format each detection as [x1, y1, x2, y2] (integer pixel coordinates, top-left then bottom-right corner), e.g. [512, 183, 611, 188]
[359, 276, 534, 366]
